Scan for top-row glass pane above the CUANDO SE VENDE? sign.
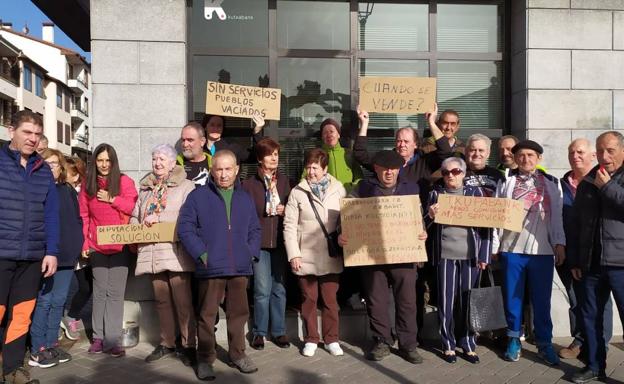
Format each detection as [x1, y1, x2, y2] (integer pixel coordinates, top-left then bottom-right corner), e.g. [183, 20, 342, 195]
[358, 2, 429, 51]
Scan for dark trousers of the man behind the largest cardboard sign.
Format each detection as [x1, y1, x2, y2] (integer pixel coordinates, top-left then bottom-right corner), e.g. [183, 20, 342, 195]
[362, 263, 418, 351]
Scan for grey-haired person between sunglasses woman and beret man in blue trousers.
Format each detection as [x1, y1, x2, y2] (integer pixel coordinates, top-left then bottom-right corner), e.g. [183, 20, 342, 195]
[464, 133, 505, 197]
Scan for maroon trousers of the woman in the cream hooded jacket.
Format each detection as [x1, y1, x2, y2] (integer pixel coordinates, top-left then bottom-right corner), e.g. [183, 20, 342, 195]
[299, 273, 340, 345]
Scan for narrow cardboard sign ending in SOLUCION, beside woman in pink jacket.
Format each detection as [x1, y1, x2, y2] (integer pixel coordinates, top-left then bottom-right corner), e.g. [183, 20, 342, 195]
[97, 223, 178, 245]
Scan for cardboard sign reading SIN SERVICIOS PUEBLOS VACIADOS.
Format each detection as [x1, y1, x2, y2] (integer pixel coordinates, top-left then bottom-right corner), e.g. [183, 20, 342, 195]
[206, 81, 282, 120]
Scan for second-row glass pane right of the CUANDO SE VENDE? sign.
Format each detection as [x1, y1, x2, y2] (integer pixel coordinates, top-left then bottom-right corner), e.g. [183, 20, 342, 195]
[438, 61, 503, 132]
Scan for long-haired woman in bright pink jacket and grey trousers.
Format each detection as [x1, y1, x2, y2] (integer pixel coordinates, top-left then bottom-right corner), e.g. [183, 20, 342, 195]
[78, 144, 137, 357]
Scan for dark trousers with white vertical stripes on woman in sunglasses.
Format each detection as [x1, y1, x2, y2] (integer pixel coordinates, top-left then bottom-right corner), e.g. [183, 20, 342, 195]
[438, 259, 479, 353]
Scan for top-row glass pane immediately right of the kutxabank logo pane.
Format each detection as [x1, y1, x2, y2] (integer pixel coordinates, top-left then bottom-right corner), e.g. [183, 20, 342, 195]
[277, 0, 350, 50]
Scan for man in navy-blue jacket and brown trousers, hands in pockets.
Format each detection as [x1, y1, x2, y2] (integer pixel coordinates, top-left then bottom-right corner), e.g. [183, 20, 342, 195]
[178, 150, 262, 380]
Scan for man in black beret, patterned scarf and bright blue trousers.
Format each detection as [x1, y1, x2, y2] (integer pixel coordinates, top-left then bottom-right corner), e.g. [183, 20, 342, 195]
[493, 140, 566, 365]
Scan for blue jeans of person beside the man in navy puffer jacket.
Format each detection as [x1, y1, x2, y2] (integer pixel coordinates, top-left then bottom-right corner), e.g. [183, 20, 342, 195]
[30, 267, 74, 351]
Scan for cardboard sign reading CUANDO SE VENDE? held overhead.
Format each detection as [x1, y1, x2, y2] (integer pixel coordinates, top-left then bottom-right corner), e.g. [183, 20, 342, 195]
[360, 77, 436, 115]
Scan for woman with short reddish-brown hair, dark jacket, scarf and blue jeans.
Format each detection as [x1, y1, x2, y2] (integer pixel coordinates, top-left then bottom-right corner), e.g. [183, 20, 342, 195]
[243, 137, 290, 350]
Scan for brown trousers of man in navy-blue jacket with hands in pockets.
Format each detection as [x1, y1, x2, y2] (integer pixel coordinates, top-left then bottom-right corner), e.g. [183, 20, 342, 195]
[197, 276, 249, 364]
